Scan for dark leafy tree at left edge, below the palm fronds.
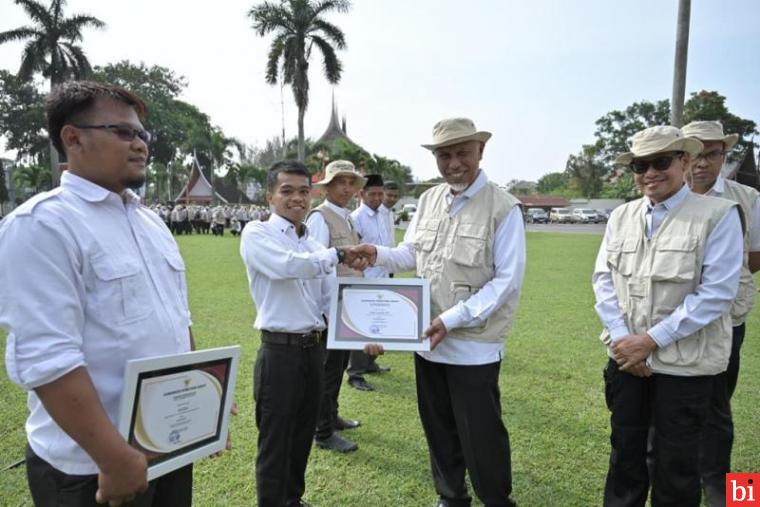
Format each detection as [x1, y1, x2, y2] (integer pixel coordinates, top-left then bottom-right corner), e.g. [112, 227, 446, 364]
[0, 70, 49, 164]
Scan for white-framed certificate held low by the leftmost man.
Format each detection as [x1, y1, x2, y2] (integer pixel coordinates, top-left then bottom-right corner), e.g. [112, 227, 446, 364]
[119, 346, 240, 481]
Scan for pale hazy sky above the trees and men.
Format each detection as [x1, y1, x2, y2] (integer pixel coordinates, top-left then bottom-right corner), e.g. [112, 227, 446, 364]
[0, 0, 760, 184]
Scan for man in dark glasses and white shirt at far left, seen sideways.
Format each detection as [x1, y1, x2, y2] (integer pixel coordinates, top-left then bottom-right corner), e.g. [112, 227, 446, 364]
[0, 81, 199, 506]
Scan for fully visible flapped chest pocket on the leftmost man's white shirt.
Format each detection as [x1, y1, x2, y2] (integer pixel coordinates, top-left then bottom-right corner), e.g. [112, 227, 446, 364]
[90, 254, 153, 325]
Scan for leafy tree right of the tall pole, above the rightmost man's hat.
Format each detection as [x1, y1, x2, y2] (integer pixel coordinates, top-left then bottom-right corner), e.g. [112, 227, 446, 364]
[683, 90, 758, 160]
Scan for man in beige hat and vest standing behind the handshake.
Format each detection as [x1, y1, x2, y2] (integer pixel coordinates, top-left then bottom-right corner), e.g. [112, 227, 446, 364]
[306, 160, 366, 452]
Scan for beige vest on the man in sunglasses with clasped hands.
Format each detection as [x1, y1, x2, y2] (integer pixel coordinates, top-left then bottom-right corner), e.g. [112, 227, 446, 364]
[607, 192, 735, 376]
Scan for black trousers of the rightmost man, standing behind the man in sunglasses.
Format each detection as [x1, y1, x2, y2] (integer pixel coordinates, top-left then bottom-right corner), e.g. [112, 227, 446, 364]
[699, 324, 745, 491]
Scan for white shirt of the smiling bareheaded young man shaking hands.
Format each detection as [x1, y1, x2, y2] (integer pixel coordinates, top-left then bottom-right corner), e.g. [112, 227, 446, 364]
[240, 213, 338, 333]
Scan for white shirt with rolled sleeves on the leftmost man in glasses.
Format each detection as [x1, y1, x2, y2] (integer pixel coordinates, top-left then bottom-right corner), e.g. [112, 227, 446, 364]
[0, 171, 190, 474]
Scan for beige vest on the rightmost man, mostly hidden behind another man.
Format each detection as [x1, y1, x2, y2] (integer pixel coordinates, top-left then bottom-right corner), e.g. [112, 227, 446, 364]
[722, 180, 760, 326]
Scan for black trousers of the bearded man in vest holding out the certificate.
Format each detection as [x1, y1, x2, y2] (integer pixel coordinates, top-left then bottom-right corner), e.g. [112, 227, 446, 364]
[414, 354, 512, 507]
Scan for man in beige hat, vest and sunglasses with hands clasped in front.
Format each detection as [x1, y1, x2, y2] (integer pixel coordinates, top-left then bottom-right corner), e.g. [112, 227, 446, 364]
[592, 126, 743, 507]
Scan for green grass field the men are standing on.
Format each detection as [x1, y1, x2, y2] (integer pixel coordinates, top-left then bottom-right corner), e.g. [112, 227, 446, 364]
[0, 233, 760, 507]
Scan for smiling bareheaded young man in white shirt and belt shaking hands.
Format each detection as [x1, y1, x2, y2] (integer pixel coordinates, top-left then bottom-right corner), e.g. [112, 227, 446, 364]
[240, 160, 366, 507]
